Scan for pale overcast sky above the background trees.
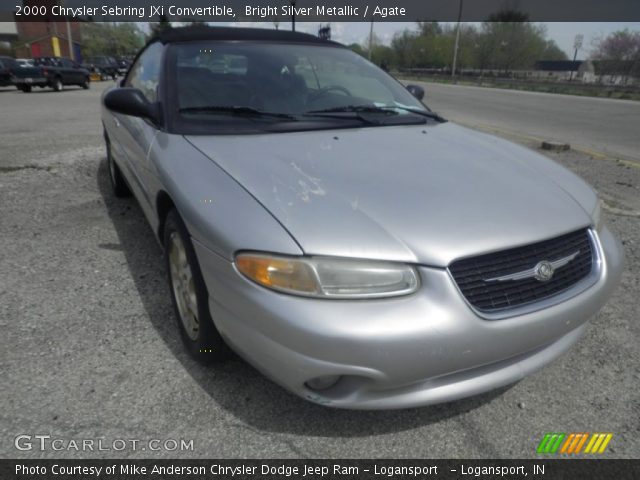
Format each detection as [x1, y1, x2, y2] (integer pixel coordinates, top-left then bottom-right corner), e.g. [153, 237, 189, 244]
[215, 22, 640, 60]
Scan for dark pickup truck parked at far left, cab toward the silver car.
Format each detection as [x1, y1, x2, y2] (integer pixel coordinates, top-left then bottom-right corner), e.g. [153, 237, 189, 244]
[13, 57, 90, 93]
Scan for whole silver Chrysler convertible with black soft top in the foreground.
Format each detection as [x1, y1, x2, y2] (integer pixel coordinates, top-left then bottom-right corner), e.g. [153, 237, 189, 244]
[102, 27, 623, 409]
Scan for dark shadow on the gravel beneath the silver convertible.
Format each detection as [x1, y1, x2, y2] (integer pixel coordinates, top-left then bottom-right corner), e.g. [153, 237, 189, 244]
[97, 158, 511, 437]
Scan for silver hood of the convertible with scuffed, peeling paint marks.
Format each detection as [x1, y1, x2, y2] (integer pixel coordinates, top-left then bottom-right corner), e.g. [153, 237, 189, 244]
[187, 123, 595, 267]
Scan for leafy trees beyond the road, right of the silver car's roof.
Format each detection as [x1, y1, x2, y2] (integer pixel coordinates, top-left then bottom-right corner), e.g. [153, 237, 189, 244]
[350, 21, 640, 76]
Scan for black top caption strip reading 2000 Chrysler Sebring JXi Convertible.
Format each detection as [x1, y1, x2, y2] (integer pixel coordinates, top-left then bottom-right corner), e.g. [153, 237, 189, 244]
[0, 0, 640, 22]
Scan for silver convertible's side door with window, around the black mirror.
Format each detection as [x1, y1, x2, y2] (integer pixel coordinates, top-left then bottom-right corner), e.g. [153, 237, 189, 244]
[114, 42, 164, 217]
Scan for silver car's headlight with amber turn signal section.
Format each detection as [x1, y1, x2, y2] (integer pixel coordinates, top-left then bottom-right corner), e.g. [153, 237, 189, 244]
[236, 253, 419, 298]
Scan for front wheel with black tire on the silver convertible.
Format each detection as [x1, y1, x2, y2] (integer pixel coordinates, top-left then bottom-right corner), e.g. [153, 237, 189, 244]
[163, 209, 230, 364]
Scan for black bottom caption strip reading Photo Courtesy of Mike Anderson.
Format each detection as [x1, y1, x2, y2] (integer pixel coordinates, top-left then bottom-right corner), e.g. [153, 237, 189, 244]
[0, 459, 640, 480]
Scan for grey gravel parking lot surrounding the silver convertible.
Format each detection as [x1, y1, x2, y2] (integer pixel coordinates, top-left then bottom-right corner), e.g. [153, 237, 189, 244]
[0, 82, 640, 458]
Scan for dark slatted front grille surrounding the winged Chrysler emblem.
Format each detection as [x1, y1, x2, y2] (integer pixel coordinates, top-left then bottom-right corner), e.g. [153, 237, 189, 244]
[449, 229, 593, 312]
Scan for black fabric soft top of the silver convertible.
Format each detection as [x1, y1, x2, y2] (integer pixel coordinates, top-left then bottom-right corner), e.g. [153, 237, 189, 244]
[149, 25, 344, 47]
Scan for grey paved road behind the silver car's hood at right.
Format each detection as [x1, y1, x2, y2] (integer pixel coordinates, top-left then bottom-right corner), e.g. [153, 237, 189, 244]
[412, 82, 640, 160]
